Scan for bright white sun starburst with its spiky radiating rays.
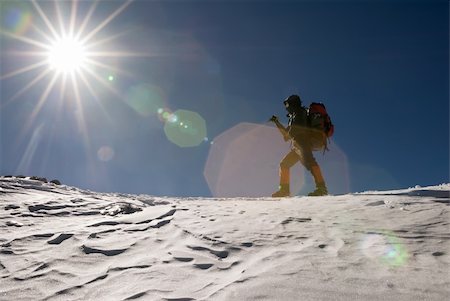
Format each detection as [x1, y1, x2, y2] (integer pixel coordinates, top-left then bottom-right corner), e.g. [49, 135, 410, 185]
[0, 0, 136, 99]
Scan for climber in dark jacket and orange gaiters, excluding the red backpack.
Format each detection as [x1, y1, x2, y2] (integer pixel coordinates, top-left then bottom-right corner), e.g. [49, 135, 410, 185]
[270, 95, 328, 197]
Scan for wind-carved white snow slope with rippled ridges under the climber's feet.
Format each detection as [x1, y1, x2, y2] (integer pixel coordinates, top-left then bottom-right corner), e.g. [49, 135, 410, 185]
[0, 177, 450, 300]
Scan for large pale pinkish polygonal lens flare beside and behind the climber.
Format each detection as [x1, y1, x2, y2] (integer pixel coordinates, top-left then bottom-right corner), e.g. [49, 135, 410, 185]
[203, 123, 304, 197]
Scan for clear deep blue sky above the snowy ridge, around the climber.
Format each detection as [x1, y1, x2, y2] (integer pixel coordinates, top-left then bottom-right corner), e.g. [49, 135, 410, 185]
[0, 0, 449, 196]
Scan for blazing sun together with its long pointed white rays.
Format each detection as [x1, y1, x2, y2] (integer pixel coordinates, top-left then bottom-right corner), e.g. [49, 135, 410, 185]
[0, 0, 137, 98]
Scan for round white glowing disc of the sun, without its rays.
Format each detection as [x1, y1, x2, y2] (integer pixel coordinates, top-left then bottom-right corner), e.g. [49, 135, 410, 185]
[47, 36, 88, 73]
